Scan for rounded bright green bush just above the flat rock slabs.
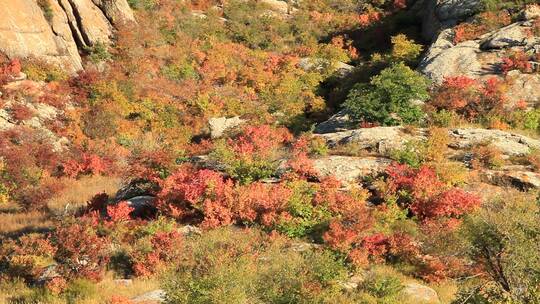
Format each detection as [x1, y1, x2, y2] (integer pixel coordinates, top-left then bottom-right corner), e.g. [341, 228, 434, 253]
[344, 63, 428, 125]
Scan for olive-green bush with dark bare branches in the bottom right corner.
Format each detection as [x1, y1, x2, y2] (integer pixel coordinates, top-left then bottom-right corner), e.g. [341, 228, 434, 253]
[463, 194, 540, 303]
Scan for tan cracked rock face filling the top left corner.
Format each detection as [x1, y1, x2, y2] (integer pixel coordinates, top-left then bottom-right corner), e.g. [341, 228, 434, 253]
[0, 0, 135, 73]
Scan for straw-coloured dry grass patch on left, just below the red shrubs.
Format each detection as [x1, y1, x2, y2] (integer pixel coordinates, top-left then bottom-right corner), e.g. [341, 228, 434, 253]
[47, 175, 121, 214]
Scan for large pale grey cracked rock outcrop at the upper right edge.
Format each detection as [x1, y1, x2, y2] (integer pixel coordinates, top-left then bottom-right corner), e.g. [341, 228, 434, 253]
[419, 1, 540, 105]
